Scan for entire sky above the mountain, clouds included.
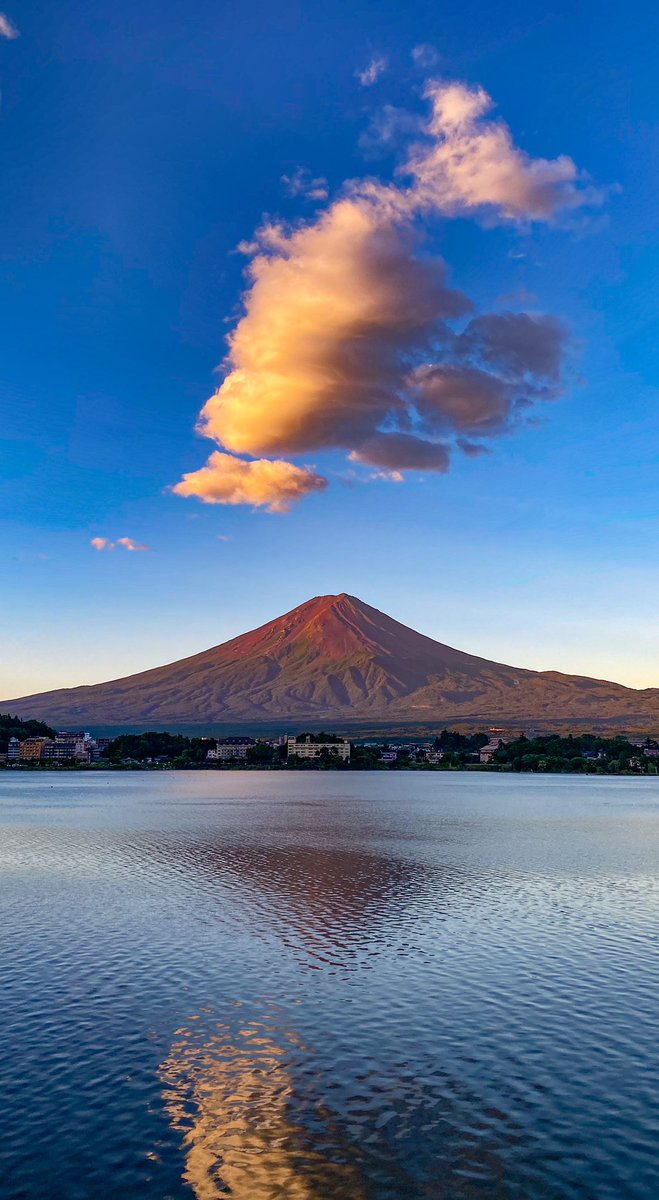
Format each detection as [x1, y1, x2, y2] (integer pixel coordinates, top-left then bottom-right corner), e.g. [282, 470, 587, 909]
[0, 0, 659, 697]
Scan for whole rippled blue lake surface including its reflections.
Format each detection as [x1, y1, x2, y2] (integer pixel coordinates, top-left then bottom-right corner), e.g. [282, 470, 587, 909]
[0, 772, 659, 1200]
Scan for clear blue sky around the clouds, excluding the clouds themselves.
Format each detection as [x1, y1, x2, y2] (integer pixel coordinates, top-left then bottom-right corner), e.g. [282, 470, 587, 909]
[0, 0, 659, 696]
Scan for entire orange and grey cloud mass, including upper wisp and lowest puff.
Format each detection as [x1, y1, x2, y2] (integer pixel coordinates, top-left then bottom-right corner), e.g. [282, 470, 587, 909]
[174, 83, 601, 512]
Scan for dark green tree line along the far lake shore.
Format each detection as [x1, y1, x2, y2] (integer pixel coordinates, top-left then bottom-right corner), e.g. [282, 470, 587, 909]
[0, 714, 659, 775]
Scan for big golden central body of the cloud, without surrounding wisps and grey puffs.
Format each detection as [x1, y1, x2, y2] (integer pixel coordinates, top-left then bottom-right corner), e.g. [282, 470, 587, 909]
[199, 199, 471, 455]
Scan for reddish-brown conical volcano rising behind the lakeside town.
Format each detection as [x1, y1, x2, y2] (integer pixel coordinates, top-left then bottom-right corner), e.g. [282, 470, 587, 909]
[5, 593, 659, 730]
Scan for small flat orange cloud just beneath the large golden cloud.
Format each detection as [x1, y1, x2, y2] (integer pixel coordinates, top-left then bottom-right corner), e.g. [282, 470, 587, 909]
[173, 450, 328, 512]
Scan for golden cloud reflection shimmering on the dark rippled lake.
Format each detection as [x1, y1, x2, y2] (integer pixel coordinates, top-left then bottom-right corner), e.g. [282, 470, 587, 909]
[161, 1018, 365, 1200]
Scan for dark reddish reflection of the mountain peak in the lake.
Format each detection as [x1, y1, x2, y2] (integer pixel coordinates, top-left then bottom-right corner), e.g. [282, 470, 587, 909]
[133, 836, 472, 974]
